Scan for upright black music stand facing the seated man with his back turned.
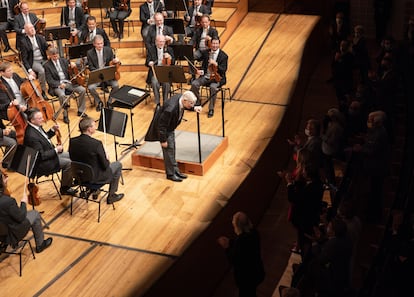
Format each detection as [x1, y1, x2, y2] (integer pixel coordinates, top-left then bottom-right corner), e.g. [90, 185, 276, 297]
[98, 108, 128, 160]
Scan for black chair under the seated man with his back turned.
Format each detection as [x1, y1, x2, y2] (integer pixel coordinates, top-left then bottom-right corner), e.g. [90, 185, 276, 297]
[70, 161, 115, 223]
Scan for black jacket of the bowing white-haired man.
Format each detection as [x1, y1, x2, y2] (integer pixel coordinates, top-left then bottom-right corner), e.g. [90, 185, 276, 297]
[158, 94, 182, 142]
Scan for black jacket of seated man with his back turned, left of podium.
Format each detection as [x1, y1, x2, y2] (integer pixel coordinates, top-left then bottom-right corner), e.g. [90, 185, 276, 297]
[69, 134, 112, 183]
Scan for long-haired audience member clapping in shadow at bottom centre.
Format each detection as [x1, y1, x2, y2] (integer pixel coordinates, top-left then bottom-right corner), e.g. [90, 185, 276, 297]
[217, 211, 265, 297]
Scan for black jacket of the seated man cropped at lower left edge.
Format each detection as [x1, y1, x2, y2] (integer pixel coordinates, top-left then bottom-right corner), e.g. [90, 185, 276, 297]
[0, 194, 30, 247]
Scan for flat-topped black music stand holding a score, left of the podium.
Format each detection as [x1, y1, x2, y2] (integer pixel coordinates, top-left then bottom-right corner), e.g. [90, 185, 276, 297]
[111, 85, 149, 151]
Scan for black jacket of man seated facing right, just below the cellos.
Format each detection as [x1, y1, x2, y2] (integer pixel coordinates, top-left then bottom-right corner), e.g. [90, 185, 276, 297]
[23, 124, 60, 176]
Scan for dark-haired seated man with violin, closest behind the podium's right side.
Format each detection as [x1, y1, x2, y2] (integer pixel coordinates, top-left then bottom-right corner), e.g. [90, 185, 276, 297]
[191, 38, 229, 118]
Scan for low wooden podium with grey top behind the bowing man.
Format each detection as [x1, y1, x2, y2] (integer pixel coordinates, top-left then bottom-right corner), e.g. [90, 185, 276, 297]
[132, 130, 228, 176]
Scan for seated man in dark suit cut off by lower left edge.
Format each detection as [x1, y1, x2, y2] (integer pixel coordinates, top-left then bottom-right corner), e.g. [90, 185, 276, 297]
[0, 174, 53, 253]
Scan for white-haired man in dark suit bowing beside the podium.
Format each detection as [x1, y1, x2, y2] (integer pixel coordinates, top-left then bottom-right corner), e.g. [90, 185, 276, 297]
[156, 91, 202, 182]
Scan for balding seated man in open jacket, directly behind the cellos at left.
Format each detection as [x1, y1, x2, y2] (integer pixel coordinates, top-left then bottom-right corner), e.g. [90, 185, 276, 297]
[20, 24, 49, 100]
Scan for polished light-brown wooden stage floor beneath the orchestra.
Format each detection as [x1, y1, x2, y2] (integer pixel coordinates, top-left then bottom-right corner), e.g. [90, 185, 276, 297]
[0, 2, 318, 296]
